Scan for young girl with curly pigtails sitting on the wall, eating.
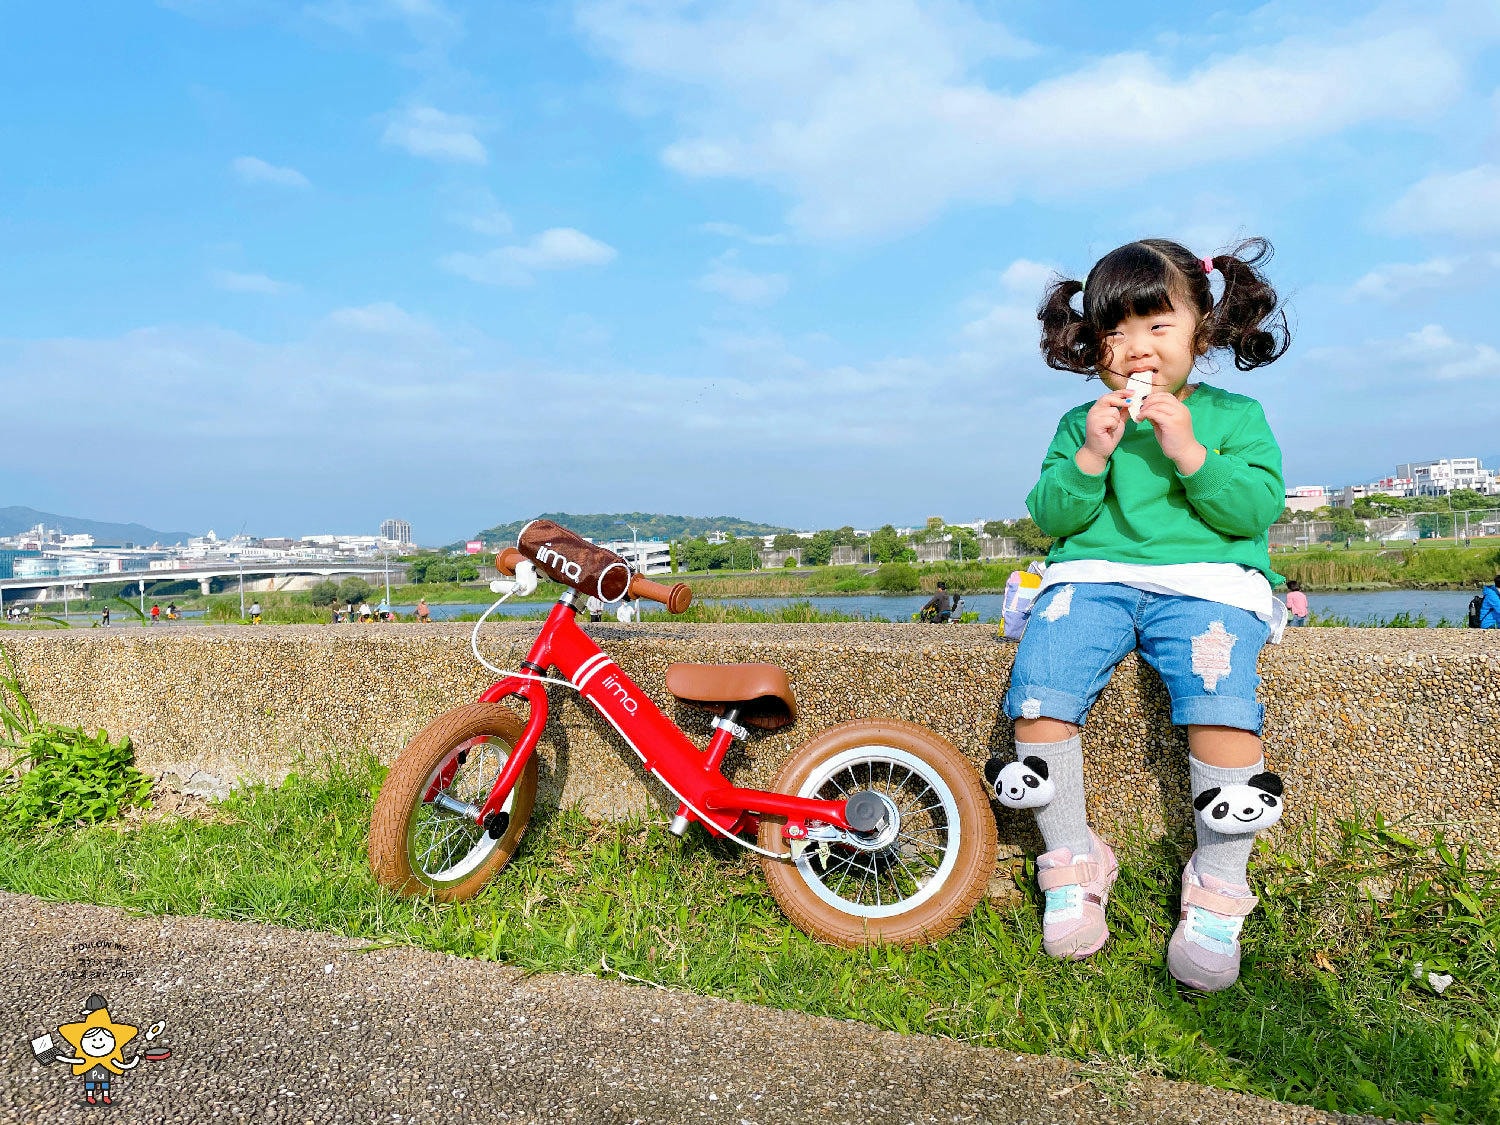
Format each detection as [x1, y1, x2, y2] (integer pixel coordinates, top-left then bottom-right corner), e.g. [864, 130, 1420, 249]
[989, 239, 1290, 992]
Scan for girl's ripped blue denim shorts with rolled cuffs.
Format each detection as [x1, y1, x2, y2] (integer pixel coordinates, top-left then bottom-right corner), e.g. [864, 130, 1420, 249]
[1005, 582, 1271, 735]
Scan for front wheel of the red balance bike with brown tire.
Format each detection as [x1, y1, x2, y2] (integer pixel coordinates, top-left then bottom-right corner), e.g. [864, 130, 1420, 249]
[371, 704, 537, 903]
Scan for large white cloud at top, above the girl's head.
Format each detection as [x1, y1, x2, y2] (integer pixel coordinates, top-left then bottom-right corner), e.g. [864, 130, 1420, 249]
[581, 0, 1493, 237]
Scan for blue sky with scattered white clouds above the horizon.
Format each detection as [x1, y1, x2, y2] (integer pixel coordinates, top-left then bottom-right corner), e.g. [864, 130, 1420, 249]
[0, 0, 1500, 543]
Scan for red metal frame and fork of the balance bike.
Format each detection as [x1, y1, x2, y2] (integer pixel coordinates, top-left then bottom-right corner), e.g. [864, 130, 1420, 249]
[476, 591, 849, 851]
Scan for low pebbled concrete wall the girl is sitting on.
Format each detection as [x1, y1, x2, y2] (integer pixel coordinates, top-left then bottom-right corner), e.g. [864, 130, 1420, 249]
[0, 620, 1500, 849]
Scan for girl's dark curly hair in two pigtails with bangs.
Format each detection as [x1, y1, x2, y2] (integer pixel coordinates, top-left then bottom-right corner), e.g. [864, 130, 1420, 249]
[1037, 239, 1292, 375]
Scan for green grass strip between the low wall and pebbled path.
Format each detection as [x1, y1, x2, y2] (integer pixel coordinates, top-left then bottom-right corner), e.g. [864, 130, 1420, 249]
[0, 759, 1500, 1122]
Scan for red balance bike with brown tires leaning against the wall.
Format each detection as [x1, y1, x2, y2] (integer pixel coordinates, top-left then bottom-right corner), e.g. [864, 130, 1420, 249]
[371, 521, 996, 947]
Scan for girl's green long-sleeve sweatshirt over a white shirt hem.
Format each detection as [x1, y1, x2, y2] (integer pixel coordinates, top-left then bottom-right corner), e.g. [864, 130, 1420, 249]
[1026, 383, 1286, 585]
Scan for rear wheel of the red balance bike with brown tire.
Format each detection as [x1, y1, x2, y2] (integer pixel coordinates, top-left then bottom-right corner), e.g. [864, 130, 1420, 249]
[759, 719, 996, 947]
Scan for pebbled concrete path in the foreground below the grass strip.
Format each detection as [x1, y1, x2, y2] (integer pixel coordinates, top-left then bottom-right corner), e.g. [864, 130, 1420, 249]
[0, 893, 1404, 1125]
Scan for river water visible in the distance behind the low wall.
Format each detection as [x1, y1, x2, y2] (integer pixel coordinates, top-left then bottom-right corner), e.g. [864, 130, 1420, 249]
[23, 590, 1475, 627]
